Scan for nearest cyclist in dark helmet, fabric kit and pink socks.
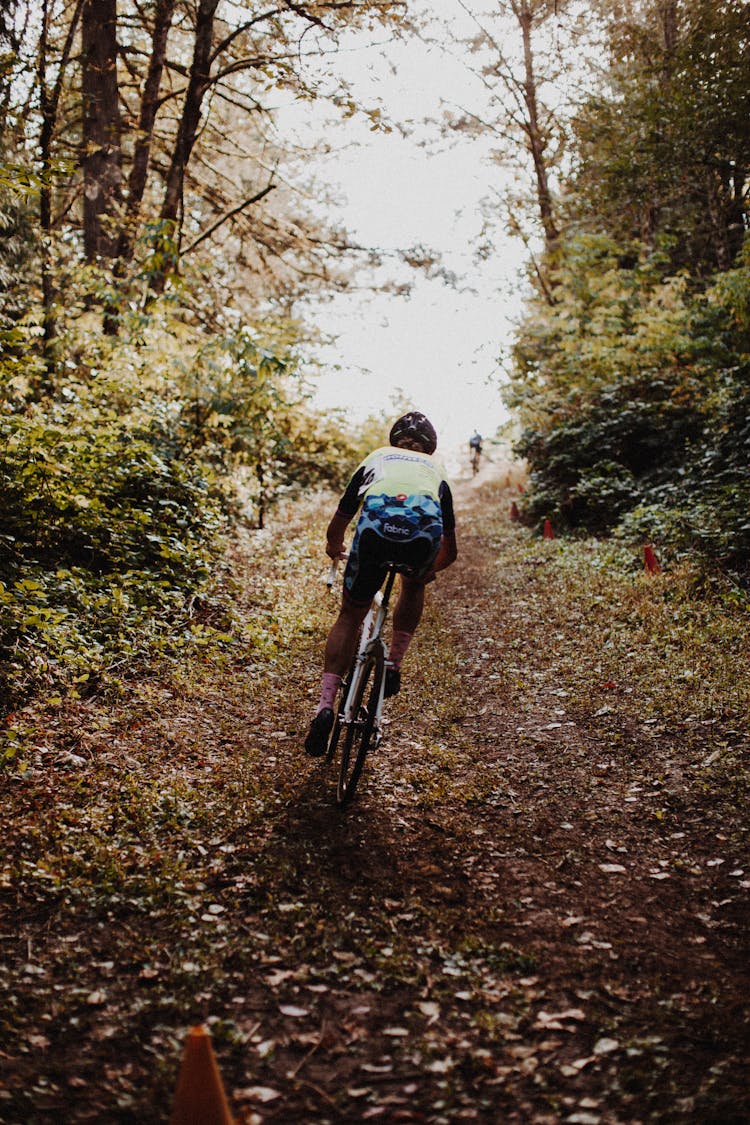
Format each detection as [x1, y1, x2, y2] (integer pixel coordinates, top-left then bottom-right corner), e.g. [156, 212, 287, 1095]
[305, 411, 458, 757]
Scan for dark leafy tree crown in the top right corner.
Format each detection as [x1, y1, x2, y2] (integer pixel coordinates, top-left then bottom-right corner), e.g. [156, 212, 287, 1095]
[567, 0, 750, 278]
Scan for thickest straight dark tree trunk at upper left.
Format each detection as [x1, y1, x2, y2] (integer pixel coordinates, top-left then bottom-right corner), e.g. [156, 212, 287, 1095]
[81, 0, 121, 262]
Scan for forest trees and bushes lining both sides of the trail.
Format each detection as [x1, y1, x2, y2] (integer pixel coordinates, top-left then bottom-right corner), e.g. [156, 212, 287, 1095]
[0, 0, 750, 701]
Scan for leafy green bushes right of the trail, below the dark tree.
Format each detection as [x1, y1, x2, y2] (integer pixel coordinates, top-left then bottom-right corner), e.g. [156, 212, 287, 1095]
[508, 232, 750, 570]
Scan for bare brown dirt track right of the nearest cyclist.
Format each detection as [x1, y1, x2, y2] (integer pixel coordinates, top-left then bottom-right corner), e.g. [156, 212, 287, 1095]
[368, 461, 750, 1122]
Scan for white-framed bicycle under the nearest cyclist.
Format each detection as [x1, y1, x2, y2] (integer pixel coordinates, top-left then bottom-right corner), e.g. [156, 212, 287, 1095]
[325, 563, 398, 809]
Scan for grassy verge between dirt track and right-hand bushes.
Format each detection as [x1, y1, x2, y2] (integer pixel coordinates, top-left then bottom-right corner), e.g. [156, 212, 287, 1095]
[481, 474, 750, 810]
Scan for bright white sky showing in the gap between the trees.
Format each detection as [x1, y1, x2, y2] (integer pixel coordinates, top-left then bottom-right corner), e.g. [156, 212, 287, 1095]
[282, 0, 530, 456]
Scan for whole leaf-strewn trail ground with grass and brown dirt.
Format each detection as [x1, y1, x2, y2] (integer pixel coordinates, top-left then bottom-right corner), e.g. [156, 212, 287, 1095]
[0, 461, 750, 1125]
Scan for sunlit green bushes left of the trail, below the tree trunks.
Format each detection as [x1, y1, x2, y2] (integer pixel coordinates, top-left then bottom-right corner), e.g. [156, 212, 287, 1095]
[0, 285, 373, 705]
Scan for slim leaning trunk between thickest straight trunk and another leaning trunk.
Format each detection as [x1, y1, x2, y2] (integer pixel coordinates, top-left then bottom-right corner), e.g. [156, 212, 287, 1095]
[117, 0, 177, 262]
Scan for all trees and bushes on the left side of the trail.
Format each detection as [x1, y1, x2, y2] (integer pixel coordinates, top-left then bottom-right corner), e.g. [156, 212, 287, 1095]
[0, 0, 404, 703]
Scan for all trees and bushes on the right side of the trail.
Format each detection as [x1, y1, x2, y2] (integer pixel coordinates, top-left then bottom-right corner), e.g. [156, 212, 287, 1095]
[490, 0, 750, 576]
